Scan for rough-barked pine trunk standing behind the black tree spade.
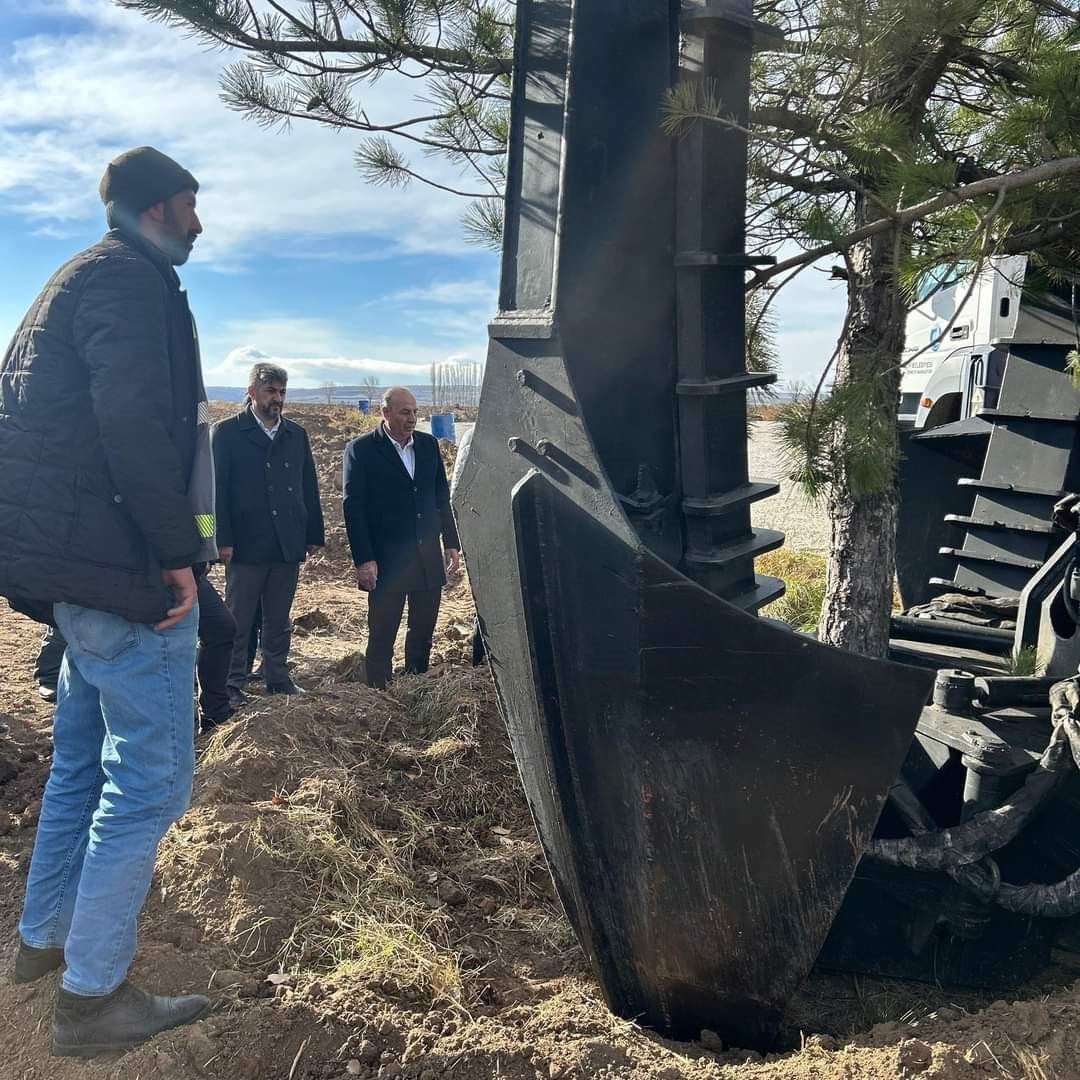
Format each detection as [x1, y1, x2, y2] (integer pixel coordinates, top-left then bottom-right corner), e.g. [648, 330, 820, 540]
[819, 225, 906, 657]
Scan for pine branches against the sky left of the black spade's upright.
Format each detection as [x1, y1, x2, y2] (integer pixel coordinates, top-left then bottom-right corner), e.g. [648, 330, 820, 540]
[116, 0, 514, 247]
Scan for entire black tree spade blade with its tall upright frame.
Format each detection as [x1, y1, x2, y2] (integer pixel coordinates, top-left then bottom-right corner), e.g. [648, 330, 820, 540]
[454, 0, 930, 1045]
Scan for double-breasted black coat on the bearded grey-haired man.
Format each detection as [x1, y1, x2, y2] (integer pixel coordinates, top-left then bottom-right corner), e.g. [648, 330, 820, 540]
[211, 406, 326, 563]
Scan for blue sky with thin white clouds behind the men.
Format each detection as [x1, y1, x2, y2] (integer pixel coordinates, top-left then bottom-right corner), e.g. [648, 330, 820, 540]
[0, 0, 842, 386]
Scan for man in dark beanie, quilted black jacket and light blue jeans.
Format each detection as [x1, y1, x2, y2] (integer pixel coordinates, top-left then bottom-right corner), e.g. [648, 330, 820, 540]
[0, 147, 215, 1056]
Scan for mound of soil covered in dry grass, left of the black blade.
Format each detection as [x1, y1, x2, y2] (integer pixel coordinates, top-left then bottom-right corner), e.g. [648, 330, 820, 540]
[163, 669, 540, 1008]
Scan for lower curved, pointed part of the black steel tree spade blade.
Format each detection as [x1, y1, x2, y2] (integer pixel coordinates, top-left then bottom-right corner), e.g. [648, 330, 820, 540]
[455, 335, 930, 1045]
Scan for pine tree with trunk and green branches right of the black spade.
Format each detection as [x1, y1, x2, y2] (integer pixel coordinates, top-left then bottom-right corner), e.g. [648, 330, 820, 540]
[665, 0, 1080, 656]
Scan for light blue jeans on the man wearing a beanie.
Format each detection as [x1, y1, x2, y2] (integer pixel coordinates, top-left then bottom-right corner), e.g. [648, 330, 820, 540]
[18, 604, 199, 997]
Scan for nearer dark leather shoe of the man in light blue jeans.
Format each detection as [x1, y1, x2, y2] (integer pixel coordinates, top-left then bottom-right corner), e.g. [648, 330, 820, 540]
[52, 983, 210, 1057]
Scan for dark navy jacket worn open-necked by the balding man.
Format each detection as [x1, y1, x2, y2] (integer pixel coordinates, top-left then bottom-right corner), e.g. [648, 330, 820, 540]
[341, 423, 460, 592]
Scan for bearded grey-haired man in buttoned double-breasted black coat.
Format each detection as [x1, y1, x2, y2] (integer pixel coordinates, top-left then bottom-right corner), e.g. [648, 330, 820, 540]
[213, 364, 326, 707]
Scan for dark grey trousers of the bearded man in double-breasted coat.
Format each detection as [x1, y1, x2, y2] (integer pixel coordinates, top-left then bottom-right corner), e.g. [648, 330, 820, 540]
[225, 562, 300, 690]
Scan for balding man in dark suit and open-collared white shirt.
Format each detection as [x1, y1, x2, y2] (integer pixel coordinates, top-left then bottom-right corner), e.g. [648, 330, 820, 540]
[341, 387, 461, 689]
